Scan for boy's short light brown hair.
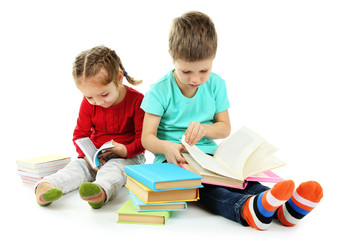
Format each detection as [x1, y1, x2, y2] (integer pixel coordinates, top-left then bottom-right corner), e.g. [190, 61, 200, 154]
[169, 12, 218, 62]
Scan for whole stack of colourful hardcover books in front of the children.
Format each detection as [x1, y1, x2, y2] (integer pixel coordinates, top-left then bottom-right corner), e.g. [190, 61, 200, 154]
[117, 163, 202, 225]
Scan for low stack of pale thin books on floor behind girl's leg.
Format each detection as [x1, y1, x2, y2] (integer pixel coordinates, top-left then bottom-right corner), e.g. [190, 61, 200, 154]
[17, 155, 71, 183]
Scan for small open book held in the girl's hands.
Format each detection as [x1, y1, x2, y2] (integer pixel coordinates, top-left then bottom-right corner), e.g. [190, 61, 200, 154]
[75, 137, 115, 168]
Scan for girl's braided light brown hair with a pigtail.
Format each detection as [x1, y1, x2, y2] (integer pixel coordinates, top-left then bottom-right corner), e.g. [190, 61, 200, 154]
[72, 46, 142, 85]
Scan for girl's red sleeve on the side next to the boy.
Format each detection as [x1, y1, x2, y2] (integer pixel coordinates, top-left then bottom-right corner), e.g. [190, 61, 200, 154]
[125, 95, 144, 158]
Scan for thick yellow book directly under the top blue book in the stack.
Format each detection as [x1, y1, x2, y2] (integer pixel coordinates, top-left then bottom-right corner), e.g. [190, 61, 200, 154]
[125, 175, 199, 204]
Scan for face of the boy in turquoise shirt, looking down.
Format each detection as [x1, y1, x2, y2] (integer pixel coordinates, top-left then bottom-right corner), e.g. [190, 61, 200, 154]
[173, 58, 213, 97]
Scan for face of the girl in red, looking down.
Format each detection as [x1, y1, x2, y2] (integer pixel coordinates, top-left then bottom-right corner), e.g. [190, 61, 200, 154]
[78, 69, 124, 108]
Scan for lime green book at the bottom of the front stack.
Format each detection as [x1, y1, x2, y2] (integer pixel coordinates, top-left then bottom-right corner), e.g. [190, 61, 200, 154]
[117, 199, 171, 225]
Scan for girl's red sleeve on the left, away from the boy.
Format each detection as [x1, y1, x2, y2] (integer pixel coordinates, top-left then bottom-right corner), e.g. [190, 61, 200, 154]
[73, 98, 92, 158]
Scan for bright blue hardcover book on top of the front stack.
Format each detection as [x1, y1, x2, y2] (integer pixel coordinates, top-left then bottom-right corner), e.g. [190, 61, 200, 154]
[124, 163, 203, 192]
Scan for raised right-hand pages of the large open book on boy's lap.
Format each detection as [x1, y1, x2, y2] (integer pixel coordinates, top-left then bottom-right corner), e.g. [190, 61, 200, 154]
[214, 127, 264, 179]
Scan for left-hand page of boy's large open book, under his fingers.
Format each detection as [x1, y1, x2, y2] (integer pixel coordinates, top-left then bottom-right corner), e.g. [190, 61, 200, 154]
[181, 137, 238, 179]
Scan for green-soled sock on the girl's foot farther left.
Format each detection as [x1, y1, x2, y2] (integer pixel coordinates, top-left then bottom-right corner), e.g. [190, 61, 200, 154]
[36, 182, 63, 206]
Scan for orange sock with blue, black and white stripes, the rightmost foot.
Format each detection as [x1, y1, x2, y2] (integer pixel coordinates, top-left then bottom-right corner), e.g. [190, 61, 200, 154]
[277, 181, 323, 227]
